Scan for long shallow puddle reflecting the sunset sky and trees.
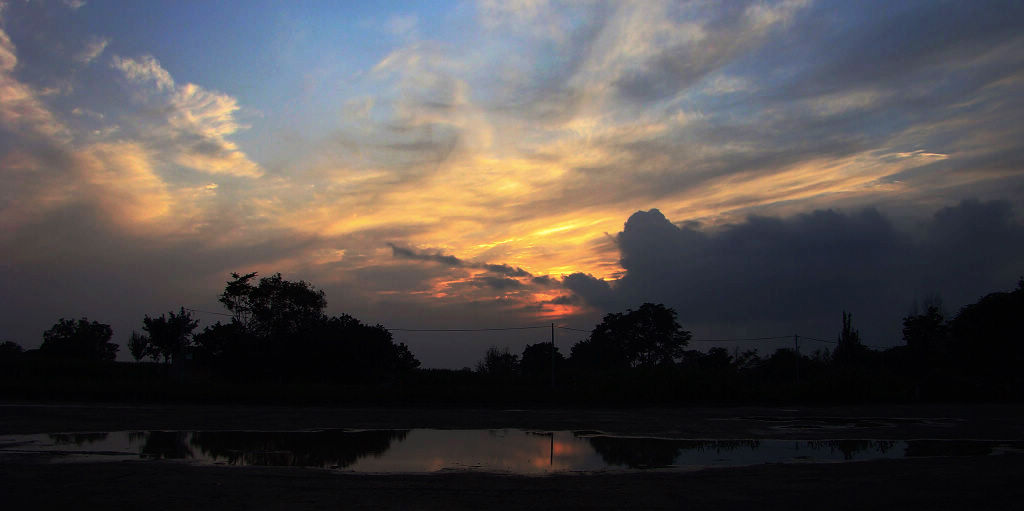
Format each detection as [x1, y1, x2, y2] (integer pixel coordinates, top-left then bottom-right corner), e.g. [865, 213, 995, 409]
[0, 429, 1024, 475]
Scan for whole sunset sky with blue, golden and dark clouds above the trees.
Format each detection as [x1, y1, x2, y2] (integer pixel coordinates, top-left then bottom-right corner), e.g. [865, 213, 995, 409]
[0, 0, 1024, 368]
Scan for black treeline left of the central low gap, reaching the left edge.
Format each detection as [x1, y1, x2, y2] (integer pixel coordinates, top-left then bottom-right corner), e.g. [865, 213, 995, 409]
[0, 273, 420, 400]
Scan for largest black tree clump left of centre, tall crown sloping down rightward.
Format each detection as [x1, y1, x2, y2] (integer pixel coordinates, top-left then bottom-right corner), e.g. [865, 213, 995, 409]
[195, 273, 420, 383]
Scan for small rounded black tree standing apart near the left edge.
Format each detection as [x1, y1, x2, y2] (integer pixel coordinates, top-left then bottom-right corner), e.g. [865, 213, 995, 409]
[39, 317, 120, 360]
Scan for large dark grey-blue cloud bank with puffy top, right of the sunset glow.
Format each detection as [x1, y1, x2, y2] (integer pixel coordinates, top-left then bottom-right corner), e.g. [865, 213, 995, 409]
[563, 201, 1024, 344]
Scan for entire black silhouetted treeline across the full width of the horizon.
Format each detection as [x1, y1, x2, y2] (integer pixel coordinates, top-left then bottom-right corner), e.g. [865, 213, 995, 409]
[0, 273, 1024, 404]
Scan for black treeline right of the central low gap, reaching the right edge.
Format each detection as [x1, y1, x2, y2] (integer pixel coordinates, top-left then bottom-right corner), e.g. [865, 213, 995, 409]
[460, 280, 1024, 402]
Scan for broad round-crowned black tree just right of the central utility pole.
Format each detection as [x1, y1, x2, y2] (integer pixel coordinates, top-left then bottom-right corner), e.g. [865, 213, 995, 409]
[571, 303, 690, 369]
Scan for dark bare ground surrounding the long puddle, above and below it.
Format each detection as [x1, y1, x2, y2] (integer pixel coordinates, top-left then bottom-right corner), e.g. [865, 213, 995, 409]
[0, 404, 1024, 509]
